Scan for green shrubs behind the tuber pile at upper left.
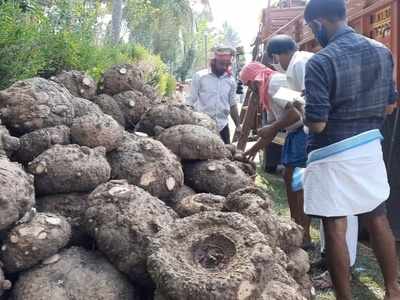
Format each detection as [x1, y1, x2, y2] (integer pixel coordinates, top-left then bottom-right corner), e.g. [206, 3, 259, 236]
[0, 0, 172, 95]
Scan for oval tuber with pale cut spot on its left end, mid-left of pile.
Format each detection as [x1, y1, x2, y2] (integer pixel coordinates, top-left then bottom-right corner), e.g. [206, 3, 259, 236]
[28, 145, 111, 195]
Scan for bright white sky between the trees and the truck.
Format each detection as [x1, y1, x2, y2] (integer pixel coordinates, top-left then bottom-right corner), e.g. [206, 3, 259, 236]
[210, 0, 268, 56]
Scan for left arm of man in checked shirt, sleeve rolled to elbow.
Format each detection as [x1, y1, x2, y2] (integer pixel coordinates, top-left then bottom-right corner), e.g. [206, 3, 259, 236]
[304, 56, 333, 133]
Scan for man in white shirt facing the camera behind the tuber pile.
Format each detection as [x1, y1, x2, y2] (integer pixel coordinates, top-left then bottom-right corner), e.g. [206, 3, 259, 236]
[186, 47, 241, 144]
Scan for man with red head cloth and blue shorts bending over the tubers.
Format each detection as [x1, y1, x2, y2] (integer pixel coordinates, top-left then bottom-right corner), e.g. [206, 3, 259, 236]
[240, 62, 311, 248]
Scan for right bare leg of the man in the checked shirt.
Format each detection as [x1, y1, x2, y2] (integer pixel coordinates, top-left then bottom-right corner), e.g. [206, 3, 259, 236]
[361, 206, 400, 300]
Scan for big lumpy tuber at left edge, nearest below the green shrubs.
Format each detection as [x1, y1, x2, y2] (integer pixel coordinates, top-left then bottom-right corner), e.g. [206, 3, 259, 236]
[0, 78, 75, 134]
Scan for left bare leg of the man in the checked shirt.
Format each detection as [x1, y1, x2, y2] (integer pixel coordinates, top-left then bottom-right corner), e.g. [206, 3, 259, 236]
[322, 217, 351, 300]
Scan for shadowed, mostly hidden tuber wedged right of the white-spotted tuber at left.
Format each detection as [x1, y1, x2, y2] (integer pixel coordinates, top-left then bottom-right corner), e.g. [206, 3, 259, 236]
[36, 193, 91, 246]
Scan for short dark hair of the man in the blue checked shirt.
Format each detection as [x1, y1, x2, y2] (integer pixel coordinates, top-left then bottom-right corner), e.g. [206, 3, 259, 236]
[304, 0, 346, 23]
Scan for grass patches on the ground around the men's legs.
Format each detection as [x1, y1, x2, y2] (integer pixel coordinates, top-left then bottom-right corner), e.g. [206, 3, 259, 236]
[256, 168, 390, 300]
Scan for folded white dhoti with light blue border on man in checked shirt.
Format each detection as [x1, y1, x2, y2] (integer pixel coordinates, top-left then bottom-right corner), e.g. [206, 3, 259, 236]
[304, 130, 390, 217]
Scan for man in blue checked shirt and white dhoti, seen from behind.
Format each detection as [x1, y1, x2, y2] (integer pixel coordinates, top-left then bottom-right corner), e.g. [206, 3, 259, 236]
[297, 0, 400, 300]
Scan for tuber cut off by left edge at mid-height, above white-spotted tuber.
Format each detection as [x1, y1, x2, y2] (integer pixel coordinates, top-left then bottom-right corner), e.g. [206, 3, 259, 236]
[0, 156, 35, 231]
